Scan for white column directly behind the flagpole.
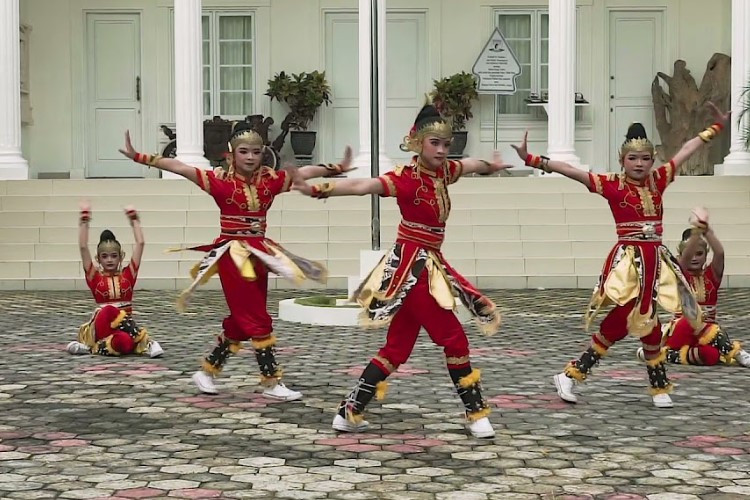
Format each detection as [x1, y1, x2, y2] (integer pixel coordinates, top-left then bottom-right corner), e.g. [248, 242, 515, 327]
[349, 0, 393, 177]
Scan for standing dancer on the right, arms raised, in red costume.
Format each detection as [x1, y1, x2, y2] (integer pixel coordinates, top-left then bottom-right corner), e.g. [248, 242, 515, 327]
[513, 100, 729, 408]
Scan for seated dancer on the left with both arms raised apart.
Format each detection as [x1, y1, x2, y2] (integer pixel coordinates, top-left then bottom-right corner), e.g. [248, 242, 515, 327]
[67, 202, 164, 358]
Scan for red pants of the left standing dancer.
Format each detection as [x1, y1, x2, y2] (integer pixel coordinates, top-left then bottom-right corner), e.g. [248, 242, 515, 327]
[219, 253, 273, 342]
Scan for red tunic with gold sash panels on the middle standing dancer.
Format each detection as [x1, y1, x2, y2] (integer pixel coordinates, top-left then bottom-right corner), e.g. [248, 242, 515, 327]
[354, 156, 500, 333]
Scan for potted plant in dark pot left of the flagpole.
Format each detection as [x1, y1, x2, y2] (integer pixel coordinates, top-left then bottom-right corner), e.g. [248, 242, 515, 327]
[266, 71, 331, 158]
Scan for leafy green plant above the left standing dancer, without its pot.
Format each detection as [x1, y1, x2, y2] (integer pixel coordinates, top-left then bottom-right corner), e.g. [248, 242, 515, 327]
[266, 71, 331, 130]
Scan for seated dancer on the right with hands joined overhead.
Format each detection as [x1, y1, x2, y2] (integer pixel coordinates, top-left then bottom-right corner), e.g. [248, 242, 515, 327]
[638, 207, 750, 367]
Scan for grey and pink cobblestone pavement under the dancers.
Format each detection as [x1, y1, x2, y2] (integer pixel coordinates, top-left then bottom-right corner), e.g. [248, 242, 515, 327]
[0, 290, 750, 500]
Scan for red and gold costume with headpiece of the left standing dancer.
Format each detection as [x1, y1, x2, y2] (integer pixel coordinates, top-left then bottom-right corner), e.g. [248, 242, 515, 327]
[178, 130, 327, 387]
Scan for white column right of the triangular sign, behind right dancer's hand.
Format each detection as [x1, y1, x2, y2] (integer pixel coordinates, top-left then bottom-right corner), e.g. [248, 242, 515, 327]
[547, 0, 584, 168]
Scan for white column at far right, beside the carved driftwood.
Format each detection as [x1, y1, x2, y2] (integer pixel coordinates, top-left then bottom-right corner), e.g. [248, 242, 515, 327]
[714, 0, 750, 175]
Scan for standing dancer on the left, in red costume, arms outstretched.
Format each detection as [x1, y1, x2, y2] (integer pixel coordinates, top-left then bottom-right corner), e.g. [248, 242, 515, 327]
[120, 122, 351, 401]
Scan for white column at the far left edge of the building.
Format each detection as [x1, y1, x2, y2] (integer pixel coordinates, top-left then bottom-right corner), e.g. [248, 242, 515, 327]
[0, 0, 29, 180]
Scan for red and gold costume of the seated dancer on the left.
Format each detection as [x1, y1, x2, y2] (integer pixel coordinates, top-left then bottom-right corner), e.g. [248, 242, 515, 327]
[78, 258, 149, 356]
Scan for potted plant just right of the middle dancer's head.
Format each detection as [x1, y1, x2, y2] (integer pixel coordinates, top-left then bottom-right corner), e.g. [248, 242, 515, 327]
[430, 71, 479, 158]
